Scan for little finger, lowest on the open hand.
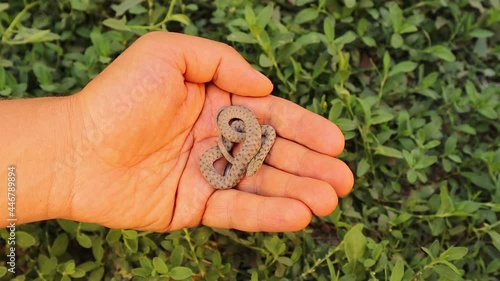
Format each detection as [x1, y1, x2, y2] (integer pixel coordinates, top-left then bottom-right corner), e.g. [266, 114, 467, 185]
[202, 189, 312, 232]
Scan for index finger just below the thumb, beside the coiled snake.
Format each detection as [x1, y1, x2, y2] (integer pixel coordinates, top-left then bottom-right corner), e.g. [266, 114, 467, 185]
[233, 96, 345, 156]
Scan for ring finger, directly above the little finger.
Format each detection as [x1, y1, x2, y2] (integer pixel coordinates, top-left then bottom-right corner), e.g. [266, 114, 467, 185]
[238, 165, 338, 216]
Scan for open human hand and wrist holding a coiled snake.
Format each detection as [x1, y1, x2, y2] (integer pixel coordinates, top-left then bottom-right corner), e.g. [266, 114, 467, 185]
[0, 32, 354, 232]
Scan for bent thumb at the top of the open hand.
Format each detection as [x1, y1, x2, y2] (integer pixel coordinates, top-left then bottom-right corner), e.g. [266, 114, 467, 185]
[131, 31, 273, 96]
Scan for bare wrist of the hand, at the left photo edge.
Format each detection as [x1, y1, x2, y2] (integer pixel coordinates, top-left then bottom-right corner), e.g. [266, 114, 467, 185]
[0, 96, 81, 226]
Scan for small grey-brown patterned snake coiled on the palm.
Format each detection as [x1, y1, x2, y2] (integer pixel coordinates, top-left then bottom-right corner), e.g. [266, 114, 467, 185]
[200, 106, 276, 189]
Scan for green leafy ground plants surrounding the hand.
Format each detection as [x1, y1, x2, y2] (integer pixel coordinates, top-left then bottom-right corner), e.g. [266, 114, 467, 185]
[0, 0, 500, 281]
